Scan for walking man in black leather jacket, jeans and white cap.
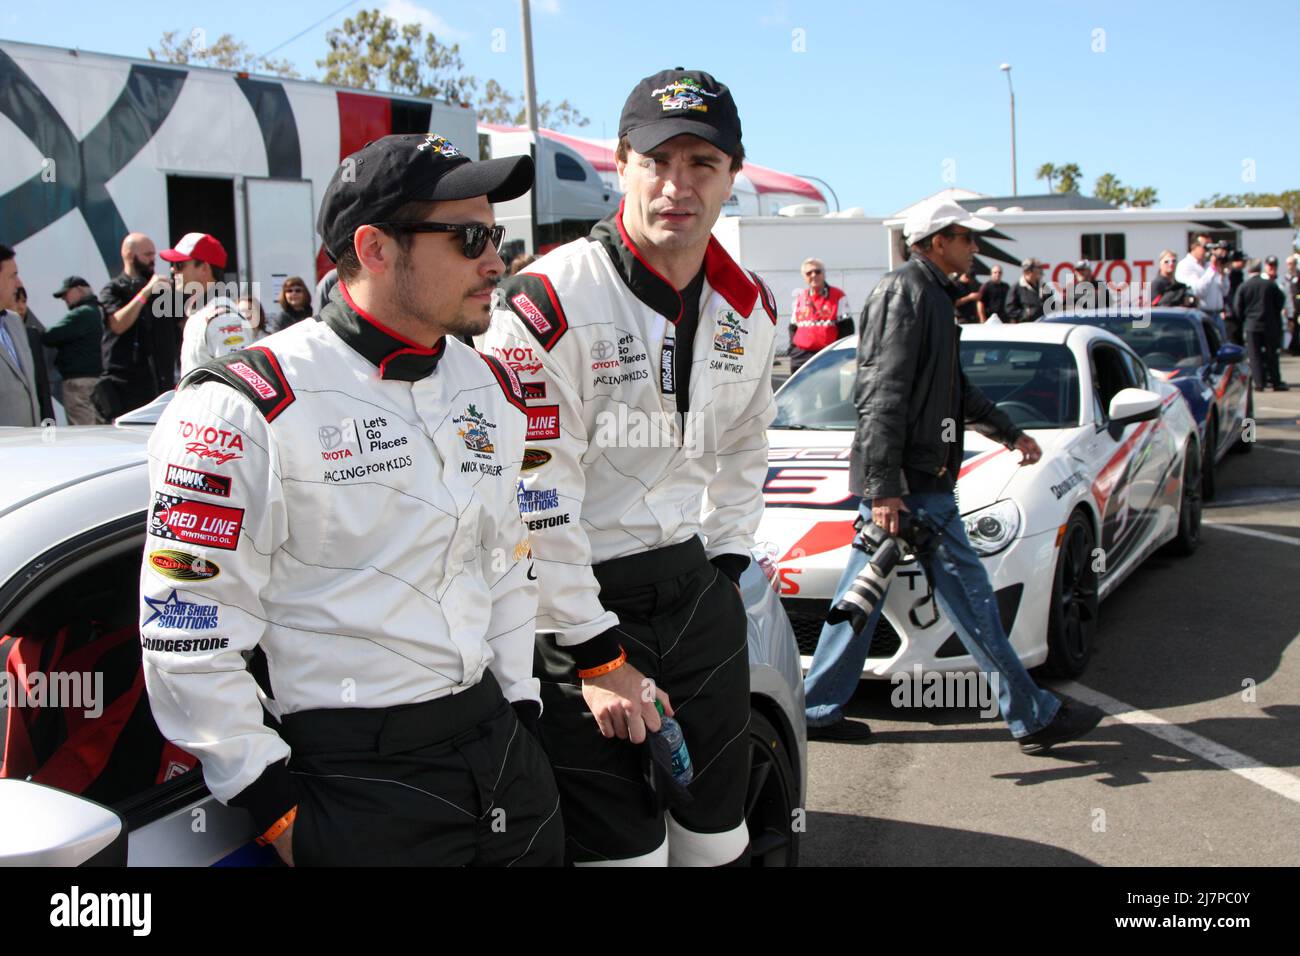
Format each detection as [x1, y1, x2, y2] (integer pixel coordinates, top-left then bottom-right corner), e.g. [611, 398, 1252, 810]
[805, 203, 1101, 754]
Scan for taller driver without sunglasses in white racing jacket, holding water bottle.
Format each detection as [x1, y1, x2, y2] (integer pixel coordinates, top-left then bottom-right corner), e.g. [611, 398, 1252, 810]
[486, 69, 776, 865]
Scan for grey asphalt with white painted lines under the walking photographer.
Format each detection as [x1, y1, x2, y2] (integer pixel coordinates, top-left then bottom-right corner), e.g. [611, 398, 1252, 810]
[801, 358, 1300, 866]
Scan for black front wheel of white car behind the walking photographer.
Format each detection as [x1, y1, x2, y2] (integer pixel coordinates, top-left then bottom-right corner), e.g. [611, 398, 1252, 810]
[1043, 511, 1099, 678]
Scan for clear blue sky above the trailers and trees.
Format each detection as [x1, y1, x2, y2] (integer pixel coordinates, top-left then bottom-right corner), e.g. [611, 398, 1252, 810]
[0, 0, 1300, 215]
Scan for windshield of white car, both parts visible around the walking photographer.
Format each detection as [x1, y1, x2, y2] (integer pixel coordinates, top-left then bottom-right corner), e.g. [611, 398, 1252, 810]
[772, 342, 1079, 431]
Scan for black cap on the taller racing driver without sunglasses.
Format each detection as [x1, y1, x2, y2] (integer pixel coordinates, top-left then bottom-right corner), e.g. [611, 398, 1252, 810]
[619, 66, 740, 155]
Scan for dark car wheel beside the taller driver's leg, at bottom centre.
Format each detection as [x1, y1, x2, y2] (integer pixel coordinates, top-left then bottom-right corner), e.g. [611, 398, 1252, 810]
[745, 710, 800, 866]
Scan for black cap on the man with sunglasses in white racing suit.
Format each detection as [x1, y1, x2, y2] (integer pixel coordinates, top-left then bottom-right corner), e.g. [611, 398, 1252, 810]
[316, 133, 533, 261]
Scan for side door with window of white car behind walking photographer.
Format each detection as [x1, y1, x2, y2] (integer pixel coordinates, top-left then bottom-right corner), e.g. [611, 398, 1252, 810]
[1088, 342, 1162, 575]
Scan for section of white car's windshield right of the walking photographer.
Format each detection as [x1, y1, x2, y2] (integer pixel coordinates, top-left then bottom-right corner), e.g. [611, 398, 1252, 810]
[962, 342, 1079, 428]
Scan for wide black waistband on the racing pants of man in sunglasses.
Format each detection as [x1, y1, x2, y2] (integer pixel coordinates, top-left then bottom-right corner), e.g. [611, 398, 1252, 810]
[280, 670, 510, 756]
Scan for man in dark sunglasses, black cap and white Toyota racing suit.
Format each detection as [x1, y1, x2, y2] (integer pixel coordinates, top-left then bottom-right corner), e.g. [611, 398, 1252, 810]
[140, 134, 563, 865]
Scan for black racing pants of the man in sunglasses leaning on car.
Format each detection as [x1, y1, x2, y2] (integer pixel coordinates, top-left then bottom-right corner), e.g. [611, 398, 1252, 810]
[281, 671, 564, 866]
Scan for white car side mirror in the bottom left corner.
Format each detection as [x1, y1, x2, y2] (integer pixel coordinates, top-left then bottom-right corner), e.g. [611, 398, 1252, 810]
[0, 779, 126, 866]
